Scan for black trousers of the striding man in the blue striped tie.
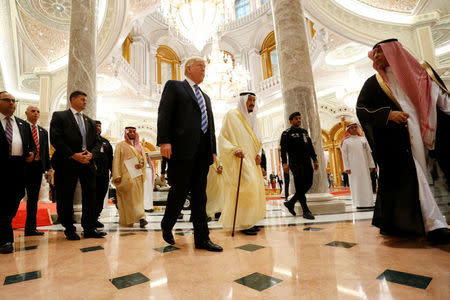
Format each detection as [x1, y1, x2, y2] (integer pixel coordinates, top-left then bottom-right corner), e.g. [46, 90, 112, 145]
[161, 134, 212, 243]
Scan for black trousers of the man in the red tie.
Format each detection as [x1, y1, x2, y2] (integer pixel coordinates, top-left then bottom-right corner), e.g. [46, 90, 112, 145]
[25, 160, 43, 231]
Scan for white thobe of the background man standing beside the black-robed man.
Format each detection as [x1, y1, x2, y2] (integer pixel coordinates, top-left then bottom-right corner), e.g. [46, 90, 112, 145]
[341, 135, 375, 207]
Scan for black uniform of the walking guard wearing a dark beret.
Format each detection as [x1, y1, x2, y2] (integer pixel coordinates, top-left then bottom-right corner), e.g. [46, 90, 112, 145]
[280, 127, 317, 216]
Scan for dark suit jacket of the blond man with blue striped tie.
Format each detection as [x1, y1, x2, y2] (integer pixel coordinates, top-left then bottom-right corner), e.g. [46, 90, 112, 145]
[157, 80, 216, 164]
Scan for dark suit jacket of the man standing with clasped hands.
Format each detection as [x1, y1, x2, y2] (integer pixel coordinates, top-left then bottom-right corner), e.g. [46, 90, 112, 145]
[50, 109, 100, 169]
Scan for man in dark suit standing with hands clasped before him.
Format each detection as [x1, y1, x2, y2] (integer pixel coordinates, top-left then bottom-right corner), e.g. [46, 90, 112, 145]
[50, 91, 106, 240]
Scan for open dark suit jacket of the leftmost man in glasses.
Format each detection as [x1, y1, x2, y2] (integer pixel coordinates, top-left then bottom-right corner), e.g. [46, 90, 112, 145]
[0, 117, 36, 164]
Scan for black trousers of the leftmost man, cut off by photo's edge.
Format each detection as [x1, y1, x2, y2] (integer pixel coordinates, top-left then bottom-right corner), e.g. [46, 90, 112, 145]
[0, 156, 25, 245]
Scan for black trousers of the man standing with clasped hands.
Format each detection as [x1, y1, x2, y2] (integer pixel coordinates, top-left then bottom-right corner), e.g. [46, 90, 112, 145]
[55, 159, 96, 232]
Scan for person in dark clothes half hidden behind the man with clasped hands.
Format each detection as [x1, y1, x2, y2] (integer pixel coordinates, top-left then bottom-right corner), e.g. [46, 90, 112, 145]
[92, 121, 113, 228]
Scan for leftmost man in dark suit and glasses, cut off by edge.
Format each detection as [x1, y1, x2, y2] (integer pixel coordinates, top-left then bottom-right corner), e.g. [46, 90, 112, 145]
[0, 91, 36, 254]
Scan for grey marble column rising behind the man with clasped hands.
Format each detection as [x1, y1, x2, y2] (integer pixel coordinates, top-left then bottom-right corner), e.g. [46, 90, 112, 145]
[67, 0, 97, 119]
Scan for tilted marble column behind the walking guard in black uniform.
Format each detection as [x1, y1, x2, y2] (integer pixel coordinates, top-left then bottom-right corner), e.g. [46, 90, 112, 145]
[271, 0, 328, 193]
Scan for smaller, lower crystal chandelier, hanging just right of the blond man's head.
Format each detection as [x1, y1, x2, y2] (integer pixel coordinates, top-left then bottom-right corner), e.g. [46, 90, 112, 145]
[202, 36, 250, 100]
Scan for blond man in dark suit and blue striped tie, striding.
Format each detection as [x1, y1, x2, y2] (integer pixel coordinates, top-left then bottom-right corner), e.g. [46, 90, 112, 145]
[157, 58, 223, 251]
